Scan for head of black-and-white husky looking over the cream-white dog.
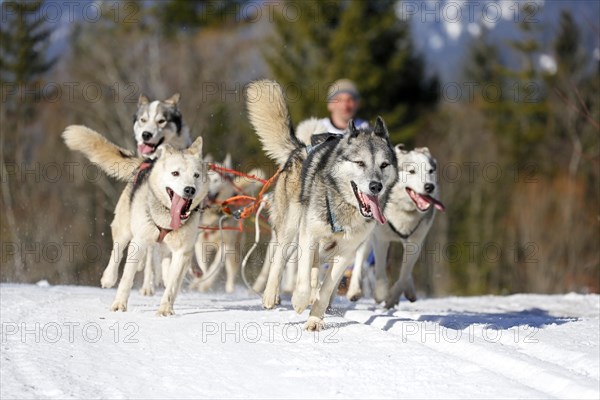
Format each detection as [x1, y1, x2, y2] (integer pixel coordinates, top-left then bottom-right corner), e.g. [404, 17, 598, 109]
[133, 93, 192, 157]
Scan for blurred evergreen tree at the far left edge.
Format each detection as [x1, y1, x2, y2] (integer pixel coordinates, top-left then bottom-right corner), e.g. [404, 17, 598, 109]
[0, 0, 56, 278]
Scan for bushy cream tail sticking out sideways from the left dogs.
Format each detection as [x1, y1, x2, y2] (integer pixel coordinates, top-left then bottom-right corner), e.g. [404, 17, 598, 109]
[62, 125, 143, 181]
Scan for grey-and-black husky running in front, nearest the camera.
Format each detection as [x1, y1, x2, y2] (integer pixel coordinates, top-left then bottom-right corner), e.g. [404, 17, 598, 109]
[247, 80, 398, 330]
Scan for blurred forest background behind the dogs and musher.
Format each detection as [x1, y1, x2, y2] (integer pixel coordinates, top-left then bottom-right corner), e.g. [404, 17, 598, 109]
[0, 0, 600, 295]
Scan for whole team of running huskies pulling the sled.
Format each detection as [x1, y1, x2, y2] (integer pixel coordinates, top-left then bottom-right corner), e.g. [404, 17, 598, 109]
[63, 80, 444, 330]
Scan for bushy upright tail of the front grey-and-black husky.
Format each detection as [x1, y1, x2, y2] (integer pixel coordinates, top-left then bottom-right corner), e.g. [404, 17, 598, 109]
[246, 80, 304, 166]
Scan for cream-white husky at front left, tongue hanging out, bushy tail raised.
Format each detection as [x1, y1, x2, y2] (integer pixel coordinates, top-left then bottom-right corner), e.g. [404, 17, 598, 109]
[63, 125, 208, 316]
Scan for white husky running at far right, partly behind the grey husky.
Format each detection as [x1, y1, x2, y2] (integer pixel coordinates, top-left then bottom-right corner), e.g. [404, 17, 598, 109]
[346, 144, 445, 308]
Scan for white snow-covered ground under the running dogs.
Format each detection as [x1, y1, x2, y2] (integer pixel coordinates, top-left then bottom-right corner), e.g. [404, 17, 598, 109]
[0, 284, 600, 399]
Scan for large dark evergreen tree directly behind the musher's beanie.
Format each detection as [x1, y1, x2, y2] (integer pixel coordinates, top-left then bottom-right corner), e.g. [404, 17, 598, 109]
[267, 0, 438, 142]
